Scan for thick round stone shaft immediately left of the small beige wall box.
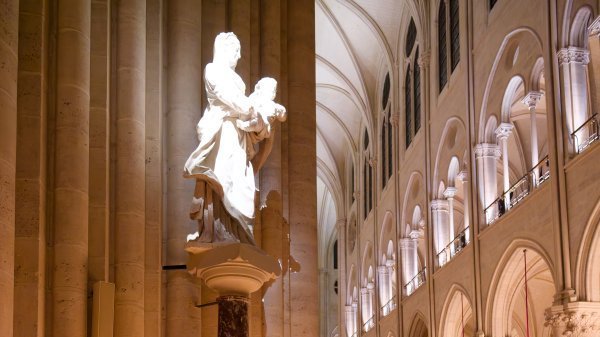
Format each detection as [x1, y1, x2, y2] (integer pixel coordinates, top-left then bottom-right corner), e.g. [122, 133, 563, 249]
[52, 0, 91, 336]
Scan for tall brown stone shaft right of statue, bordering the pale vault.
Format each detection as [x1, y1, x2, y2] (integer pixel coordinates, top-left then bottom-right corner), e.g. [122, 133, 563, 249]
[287, 0, 319, 337]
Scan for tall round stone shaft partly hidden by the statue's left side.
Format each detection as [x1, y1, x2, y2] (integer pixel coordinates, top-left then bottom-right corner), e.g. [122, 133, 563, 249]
[165, 0, 203, 337]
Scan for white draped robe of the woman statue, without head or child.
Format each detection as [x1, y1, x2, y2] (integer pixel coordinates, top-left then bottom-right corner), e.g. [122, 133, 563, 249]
[184, 63, 255, 242]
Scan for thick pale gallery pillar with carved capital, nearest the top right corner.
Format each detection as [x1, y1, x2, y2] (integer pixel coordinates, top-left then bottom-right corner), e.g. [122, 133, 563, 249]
[557, 47, 590, 151]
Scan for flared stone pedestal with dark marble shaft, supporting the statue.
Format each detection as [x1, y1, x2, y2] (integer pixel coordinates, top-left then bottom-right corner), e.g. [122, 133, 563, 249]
[186, 243, 281, 337]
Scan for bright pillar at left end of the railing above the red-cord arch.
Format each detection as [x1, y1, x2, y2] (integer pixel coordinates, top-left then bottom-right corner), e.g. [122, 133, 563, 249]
[475, 143, 500, 224]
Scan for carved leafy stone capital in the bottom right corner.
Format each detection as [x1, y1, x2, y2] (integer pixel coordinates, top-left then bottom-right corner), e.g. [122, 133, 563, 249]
[544, 302, 600, 337]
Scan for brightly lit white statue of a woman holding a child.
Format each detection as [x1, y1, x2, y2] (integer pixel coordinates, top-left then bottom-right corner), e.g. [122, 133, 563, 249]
[184, 33, 286, 244]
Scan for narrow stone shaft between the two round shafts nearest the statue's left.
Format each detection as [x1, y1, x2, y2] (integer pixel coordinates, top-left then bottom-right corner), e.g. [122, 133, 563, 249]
[144, 0, 164, 337]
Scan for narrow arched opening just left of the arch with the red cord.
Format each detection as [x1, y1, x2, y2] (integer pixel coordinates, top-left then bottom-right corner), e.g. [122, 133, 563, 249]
[440, 286, 475, 337]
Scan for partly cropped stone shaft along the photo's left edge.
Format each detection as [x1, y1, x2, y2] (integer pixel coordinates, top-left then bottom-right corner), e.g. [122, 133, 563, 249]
[0, 0, 19, 337]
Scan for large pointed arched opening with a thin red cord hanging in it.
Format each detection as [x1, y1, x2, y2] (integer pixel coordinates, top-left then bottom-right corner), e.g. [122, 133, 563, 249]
[488, 246, 556, 337]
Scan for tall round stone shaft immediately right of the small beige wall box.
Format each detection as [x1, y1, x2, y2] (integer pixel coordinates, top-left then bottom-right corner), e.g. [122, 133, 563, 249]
[114, 0, 146, 337]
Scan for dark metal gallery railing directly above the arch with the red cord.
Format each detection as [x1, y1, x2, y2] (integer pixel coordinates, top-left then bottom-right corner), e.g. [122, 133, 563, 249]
[483, 156, 550, 225]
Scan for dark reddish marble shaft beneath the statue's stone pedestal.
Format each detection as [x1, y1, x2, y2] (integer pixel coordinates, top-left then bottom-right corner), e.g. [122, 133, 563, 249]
[217, 296, 249, 337]
